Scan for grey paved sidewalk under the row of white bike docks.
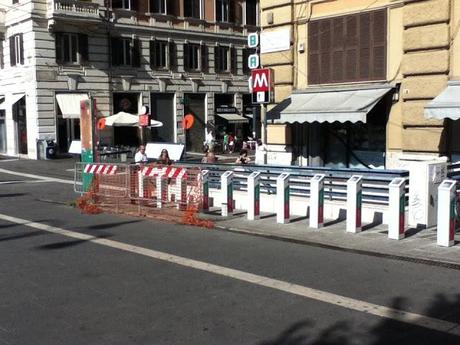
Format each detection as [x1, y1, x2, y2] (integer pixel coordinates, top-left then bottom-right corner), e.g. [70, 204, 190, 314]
[205, 209, 460, 269]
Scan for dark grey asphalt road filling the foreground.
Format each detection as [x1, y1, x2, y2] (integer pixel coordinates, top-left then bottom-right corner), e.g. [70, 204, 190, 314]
[0, 161, 460, 345]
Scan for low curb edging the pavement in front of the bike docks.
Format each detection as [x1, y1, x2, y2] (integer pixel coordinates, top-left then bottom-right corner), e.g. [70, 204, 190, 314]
[215, 225, 460, 270]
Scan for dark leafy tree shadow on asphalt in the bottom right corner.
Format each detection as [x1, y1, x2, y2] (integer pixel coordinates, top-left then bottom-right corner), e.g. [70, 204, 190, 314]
[257, 294, 460, 345]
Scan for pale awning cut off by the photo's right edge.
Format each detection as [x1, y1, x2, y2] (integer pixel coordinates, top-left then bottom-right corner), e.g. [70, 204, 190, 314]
[425, 81, 460, 120]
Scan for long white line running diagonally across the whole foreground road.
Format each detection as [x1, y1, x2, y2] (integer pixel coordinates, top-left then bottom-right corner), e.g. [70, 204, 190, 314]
[0, 214, 460, 336]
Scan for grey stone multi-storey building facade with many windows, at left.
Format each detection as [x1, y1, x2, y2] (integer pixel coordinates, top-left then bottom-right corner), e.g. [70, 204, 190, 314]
[0, 0, 259, 158]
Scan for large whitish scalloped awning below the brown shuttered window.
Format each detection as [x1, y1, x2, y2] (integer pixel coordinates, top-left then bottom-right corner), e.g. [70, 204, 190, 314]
[268, 84, 393, 123]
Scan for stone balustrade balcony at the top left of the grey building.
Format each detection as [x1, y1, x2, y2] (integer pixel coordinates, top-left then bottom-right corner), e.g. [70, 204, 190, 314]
[47, 0, 100, 20]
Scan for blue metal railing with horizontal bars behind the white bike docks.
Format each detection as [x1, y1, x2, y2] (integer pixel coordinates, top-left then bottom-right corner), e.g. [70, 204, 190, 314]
[180, 162, 410, 205]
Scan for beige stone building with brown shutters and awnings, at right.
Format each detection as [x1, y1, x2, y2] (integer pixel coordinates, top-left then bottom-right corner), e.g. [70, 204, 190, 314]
[260, 0, 460, 168]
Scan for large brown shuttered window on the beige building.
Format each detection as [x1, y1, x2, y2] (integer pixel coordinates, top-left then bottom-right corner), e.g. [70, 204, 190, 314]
[308, 10, 387, 84]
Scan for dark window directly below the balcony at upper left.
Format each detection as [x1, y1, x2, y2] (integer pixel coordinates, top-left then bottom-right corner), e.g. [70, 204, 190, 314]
[56, 33, 88, 64]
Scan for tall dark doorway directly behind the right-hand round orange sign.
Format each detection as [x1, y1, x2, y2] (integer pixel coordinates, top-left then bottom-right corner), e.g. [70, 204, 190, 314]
[184, 93, 206, 152]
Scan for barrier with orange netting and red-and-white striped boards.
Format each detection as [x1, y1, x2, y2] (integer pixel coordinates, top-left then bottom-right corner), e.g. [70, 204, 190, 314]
[74, 163, 209, 227]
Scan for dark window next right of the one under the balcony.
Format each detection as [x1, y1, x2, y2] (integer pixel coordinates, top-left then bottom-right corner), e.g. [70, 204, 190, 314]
[111, 37, 141, 67]
